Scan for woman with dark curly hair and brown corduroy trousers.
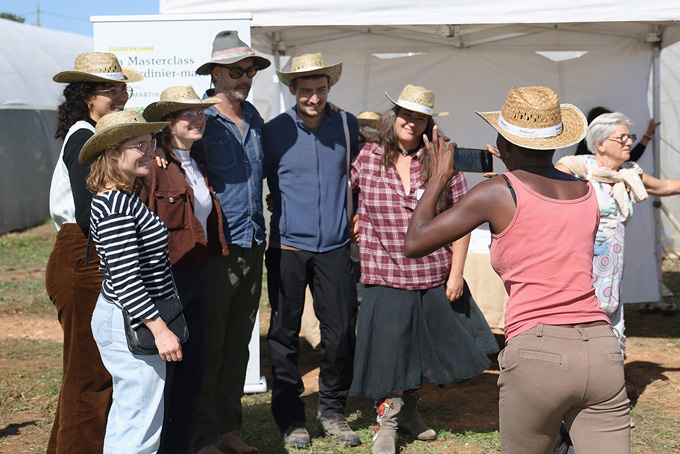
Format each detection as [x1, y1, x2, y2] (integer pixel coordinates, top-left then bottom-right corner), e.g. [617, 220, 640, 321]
[45, 52, 142, 454]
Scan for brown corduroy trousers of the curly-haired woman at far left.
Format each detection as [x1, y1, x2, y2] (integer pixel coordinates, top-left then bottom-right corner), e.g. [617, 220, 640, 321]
[45, 224, 113, 454]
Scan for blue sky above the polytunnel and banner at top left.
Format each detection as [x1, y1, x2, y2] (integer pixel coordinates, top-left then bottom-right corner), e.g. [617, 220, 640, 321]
[0, 0, 158, 36]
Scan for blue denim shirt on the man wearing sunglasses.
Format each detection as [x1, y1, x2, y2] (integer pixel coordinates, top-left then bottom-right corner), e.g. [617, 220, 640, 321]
[192, 90, 266, 247]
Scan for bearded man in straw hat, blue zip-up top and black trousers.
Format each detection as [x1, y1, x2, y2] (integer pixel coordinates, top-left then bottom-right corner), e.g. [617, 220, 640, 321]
[263, 54, 360, 448]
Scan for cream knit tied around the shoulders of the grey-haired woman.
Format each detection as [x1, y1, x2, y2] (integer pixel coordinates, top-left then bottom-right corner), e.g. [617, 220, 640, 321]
[557, 156, 647, 223]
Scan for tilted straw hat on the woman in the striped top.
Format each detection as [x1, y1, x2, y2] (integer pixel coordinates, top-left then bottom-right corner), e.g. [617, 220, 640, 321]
[78, 110, 170, 164]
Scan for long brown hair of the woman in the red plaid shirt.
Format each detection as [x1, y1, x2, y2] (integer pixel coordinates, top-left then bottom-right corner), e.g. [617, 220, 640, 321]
[373, 106, 451, 211]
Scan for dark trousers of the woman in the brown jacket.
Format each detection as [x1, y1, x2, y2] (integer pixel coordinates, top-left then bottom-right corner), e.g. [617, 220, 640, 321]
[158, 266, 210, 454]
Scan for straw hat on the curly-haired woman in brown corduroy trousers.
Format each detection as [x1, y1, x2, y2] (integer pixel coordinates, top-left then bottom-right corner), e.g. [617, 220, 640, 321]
[52, 52, 144, 84]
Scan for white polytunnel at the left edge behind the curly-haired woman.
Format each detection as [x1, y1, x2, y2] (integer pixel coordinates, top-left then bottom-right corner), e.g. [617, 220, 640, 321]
[0, 19, 92, 233]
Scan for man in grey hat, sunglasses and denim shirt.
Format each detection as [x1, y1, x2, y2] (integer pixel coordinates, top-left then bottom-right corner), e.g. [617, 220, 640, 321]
[193, 30, 271, 454]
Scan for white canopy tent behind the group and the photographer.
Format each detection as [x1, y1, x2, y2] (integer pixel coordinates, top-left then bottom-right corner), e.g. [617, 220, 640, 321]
[160, 0, 680, 302]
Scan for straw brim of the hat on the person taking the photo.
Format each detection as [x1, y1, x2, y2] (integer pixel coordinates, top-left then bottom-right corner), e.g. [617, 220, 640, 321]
[475, 104, 588, 150]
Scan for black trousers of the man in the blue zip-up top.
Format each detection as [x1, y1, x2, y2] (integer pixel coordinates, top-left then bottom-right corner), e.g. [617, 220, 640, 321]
[265, 245, 358, 432]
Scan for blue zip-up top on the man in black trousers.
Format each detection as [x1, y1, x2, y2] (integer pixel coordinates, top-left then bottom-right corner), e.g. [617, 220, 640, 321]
[263, 107, 359, 252]
